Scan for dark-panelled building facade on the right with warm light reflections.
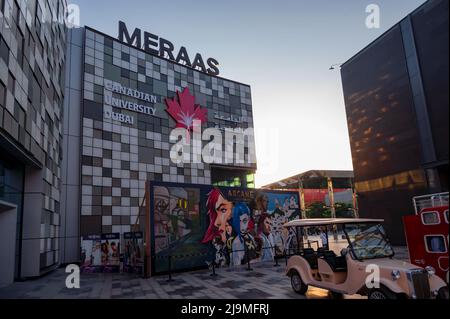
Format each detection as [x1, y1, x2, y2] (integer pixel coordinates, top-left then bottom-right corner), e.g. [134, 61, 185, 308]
[342, 0, 449, 244]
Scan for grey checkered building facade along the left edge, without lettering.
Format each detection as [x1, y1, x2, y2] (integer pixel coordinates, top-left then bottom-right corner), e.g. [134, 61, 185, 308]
[0, 0, 67, 283]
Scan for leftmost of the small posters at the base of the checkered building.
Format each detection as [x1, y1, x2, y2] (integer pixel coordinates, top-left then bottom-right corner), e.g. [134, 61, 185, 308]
[80, 235, 103, 273]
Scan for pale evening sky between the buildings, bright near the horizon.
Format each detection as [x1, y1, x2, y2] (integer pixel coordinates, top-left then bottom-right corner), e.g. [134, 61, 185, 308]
[68, 0, 425, 187]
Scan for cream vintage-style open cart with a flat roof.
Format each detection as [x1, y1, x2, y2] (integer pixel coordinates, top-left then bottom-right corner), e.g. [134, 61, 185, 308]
[284, 218, 448, 299]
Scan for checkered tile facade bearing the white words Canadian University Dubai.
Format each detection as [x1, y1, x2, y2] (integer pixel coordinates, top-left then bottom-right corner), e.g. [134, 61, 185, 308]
[63, 28, 256, 262]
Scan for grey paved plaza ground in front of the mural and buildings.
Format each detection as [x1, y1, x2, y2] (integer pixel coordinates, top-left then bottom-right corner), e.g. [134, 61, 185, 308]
[0, 249, 408, 299]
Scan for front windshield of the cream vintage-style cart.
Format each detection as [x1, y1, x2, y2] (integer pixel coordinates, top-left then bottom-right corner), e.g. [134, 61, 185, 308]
[344, 224, 394, 259]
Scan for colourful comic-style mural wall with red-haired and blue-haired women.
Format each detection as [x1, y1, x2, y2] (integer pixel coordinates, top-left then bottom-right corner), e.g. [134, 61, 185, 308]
[151, 183, 300, 274]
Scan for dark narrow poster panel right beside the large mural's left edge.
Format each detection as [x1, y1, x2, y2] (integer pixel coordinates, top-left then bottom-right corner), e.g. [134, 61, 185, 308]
[123, 232, 144, 275]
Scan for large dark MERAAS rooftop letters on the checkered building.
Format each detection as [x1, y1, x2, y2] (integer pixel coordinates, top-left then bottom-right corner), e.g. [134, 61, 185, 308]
[118, 21, 219, 76]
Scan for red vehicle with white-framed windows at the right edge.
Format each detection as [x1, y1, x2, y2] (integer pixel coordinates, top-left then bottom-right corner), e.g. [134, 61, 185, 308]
[403, 192, 449, 285]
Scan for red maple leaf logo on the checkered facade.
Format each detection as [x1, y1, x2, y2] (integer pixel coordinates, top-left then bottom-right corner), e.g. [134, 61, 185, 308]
[166, 87, 208, 130]
